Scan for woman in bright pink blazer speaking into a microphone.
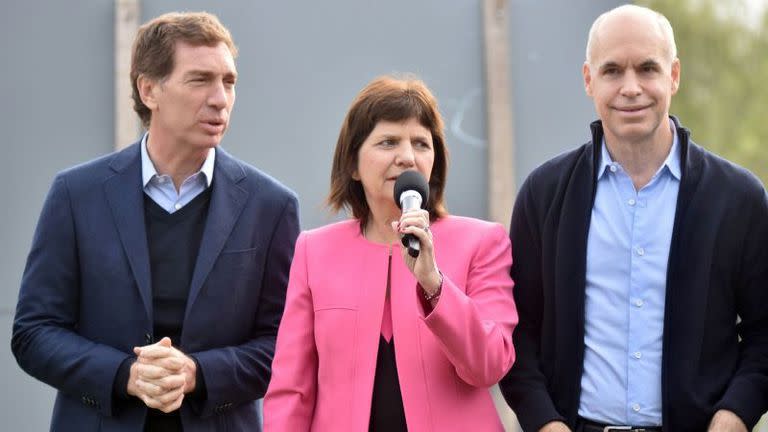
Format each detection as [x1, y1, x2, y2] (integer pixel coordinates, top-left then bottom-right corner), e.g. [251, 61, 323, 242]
[264, 77, 517, 432]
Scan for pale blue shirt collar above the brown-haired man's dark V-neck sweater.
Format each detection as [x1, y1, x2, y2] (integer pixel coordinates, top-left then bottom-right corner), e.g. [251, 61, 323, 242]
[141, 133, 216, 213]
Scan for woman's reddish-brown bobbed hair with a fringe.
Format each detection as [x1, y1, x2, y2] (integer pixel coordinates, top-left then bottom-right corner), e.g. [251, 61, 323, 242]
[327, 76, 448, 228]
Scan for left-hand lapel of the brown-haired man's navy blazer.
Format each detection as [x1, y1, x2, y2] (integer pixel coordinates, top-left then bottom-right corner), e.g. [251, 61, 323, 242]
[104, 143, 152, 322]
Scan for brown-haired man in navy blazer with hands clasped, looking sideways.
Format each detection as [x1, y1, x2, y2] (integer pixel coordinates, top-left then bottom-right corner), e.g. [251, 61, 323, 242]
[12, 13, 299, 432]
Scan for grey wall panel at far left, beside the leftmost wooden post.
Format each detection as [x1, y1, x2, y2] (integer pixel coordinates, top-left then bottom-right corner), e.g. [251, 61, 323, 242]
[0, 0, 113, 431]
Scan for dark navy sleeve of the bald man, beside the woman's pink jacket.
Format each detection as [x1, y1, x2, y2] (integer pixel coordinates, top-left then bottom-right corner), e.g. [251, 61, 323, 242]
[499, 177, 565, 431]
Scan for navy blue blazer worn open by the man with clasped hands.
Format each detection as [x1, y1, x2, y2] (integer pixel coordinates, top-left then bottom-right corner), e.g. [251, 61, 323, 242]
[11, 143, 299, 432]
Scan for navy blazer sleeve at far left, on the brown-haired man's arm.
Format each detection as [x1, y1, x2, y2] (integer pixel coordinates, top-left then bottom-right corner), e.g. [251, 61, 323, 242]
[11, 174, 130, 416]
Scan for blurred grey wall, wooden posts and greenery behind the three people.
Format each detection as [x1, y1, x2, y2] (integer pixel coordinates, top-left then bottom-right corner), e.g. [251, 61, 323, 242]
[0, 0, 768, 432]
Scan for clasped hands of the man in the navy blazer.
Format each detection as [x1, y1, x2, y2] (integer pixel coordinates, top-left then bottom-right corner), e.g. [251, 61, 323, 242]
[128, 337, 197, 413]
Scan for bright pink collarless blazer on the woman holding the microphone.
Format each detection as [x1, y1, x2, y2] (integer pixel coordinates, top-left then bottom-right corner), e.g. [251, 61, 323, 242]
[264, 216, 517, 432]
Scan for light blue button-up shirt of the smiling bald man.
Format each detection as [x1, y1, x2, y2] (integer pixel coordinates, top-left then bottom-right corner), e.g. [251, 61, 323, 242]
[579, 121, 681, 426]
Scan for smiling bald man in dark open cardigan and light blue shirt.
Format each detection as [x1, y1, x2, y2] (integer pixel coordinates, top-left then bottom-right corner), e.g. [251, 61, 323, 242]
[501, 6, 768, 432]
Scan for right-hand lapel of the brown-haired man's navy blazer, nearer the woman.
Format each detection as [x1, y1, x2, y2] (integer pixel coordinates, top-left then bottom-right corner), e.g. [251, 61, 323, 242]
[184, 148, 248, 321]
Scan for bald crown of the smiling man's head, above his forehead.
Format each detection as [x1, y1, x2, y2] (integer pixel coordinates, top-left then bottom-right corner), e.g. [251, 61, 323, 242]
[586, 5, 677, 64]
